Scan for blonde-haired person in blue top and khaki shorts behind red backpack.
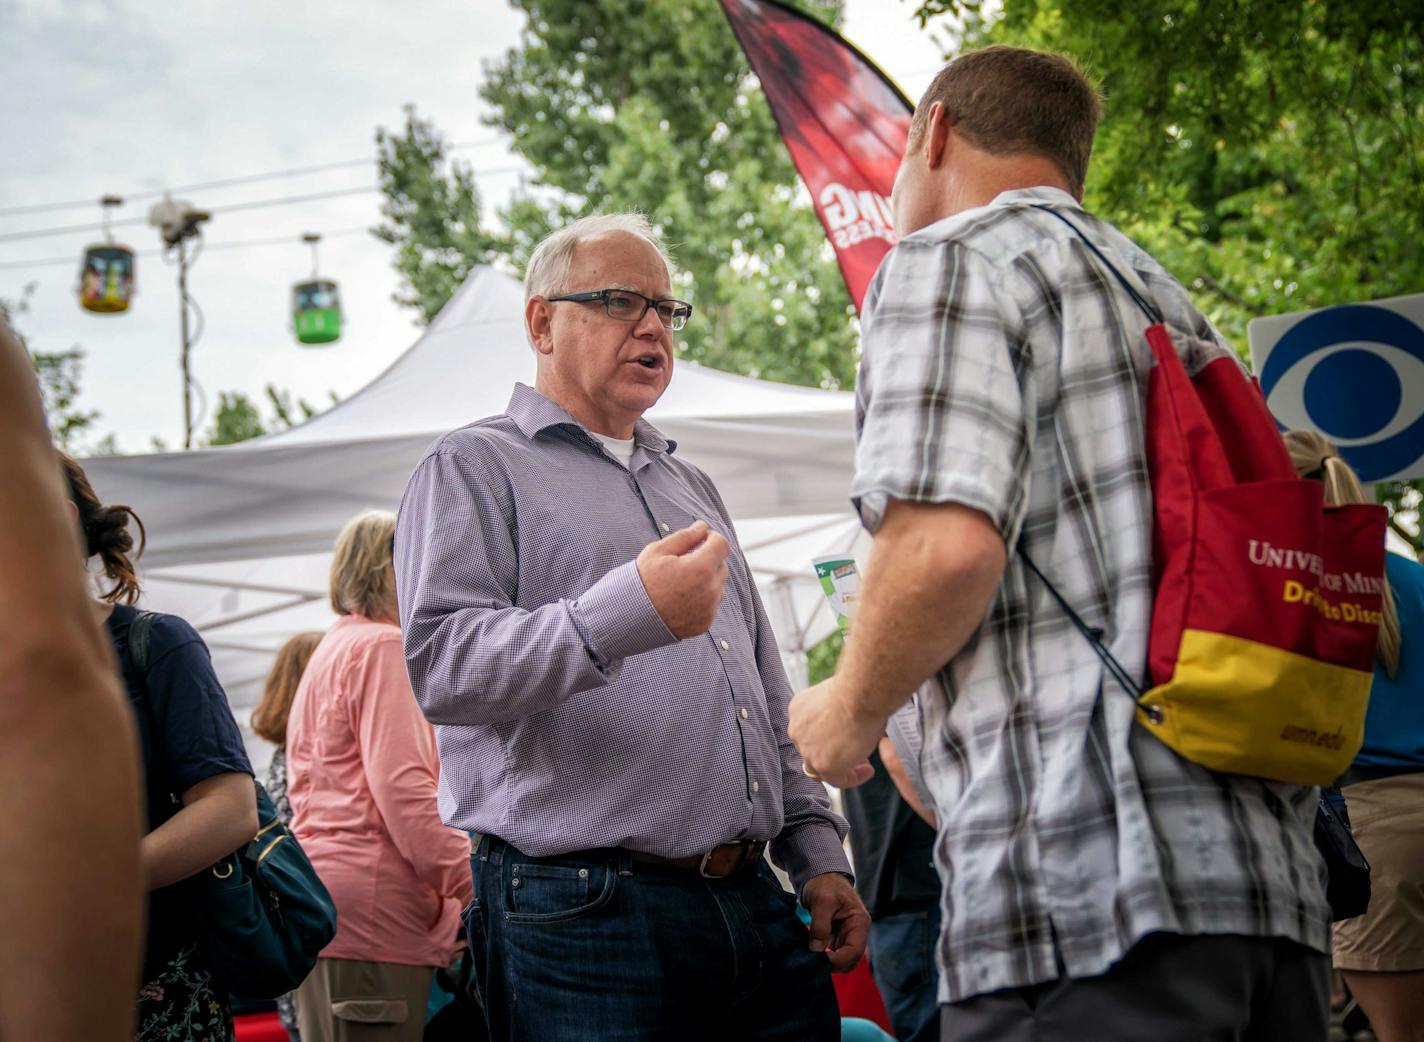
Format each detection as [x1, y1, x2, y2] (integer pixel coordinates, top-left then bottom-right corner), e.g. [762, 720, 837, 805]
[1286, 431, 1424, 1042]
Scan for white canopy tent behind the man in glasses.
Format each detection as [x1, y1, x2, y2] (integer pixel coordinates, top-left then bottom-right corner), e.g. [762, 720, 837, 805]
[85, 268, 860, 752]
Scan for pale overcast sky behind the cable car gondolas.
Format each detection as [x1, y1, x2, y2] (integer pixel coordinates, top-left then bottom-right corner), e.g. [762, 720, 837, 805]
[0, 0, 941, 451]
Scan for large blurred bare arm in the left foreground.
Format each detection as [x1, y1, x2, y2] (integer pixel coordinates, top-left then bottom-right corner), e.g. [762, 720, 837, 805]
[0, 325, 142, 1042]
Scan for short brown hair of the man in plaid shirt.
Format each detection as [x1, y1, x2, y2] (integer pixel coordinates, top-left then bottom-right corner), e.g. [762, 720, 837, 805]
[910, 44, 1102, 195]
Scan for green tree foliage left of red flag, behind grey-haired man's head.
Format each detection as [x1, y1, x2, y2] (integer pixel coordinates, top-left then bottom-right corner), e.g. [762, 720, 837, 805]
[380, 0, 856, 386]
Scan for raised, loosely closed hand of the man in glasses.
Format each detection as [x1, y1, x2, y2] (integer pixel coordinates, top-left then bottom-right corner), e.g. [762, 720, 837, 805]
[638, 521, 731, 641]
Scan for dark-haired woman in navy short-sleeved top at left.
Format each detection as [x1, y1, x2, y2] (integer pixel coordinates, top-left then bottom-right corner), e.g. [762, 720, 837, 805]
[61, 456, 258, 1042]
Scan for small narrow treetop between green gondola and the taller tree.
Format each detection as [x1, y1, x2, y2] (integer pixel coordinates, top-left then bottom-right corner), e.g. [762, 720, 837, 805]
[372, 105, 507, 322]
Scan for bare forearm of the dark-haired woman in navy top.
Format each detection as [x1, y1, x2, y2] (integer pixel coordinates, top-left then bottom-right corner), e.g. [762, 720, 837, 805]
[144, 773, 258, 890]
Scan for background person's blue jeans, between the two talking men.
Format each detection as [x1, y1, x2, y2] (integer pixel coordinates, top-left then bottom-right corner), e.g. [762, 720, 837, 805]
[867, 904, 940, 1042]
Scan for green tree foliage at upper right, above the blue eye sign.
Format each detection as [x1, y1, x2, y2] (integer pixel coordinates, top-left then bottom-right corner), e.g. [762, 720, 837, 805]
[917, 0, 1424, 548]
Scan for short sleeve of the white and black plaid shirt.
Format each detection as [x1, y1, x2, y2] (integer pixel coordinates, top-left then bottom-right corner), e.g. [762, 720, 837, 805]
[852, 238, 1035, 544]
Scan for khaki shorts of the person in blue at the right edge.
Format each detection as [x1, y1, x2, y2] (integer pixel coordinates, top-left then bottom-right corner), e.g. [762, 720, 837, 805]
[1334, 773, 1424, 972]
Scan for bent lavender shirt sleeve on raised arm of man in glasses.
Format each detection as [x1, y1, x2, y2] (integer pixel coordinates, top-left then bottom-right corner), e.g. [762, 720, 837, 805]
[396, 448, 676, 725]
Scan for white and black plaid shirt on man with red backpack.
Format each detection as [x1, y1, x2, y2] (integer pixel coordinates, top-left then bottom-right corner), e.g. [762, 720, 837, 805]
[853, 188, 1330, 1002]
